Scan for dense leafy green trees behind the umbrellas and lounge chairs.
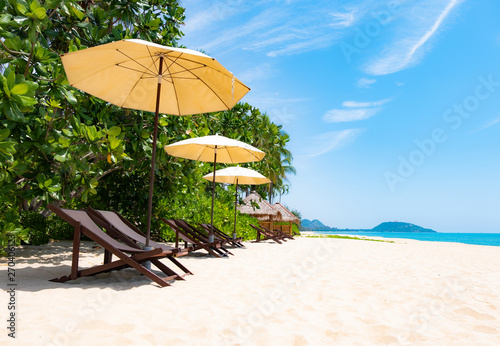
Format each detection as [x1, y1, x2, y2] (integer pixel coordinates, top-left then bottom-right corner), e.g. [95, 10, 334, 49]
[0, 0, 294, 247]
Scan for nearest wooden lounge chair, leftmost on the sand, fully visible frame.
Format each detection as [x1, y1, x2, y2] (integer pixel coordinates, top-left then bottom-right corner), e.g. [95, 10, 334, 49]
[48, 204, 184, 287]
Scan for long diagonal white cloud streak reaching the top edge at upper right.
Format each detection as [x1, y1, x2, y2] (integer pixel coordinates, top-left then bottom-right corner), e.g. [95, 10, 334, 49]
[364, 0, 465, 75]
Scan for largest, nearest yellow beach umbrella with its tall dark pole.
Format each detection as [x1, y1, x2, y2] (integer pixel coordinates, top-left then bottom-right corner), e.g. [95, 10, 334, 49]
[61, 39, 250, 247]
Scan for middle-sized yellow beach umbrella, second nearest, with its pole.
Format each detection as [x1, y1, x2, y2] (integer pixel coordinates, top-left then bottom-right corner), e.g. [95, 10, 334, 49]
[165, 135, 266, 241]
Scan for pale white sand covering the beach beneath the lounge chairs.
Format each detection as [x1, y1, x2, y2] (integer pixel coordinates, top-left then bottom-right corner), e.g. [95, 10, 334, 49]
[0, 238, 500, 345]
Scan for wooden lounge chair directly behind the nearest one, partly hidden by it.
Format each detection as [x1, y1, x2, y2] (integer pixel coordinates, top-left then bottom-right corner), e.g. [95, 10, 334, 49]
[86, 207, 193, 275]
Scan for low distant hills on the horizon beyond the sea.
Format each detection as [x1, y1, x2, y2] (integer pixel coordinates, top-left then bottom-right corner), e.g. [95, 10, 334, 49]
[300, 219, 437, 233]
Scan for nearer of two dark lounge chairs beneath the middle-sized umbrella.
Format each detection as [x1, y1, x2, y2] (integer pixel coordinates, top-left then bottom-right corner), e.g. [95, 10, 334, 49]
[161, 218, 228, 258]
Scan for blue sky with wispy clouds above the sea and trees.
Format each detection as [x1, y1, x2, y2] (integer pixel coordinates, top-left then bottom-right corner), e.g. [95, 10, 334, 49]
[181, 0, 500, 232]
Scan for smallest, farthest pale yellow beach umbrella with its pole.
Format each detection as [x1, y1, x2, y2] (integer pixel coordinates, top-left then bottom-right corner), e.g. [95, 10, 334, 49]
[203, 167, 271, 239]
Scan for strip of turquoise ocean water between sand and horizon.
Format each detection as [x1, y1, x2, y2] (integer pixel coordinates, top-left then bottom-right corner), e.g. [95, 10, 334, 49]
[315, 231, 500, 246]
